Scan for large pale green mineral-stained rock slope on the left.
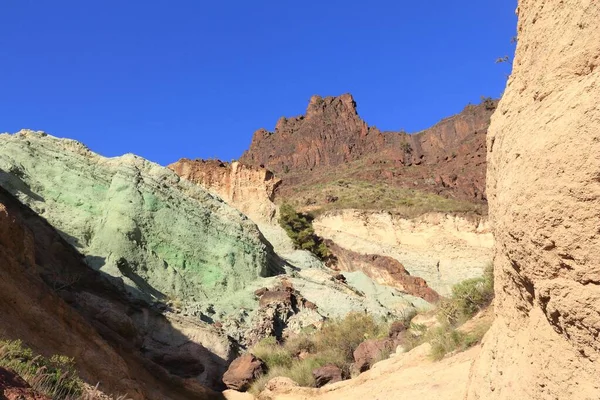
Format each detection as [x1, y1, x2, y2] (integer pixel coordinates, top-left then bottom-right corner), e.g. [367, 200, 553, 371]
[0, 131, 277, 301]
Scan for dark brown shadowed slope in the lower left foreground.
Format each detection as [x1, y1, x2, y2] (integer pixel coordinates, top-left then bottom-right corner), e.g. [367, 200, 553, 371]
[0, 188, 227, 400]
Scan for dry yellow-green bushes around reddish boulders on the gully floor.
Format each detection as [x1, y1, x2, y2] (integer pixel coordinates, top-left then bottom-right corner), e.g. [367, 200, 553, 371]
[250, 313, 389, 394]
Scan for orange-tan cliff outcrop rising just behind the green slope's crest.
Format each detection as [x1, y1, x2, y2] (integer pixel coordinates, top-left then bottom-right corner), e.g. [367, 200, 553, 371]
[168, 158, 281, 223]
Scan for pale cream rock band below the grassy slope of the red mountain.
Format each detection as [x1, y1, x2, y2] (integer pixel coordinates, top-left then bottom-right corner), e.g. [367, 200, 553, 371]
[313, 210, 494, 295]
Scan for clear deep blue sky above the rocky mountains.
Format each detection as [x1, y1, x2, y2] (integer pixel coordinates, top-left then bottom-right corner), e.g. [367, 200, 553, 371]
[0, 0, 516, 164]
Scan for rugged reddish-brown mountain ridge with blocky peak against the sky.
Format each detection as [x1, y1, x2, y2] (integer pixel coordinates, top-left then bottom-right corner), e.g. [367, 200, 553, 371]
[240, 94, 496, 201]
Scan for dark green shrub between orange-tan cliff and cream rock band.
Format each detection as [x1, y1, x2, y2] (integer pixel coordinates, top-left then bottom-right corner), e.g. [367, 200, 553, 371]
[279, 203, 330, 260]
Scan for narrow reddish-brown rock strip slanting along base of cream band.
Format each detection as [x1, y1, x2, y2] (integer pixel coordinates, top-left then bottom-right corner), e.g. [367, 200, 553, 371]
[325, 240, 440, 303]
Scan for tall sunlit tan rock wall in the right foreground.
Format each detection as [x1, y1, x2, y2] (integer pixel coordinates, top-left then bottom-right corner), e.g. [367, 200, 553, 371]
[468, 0, 600, 400]
